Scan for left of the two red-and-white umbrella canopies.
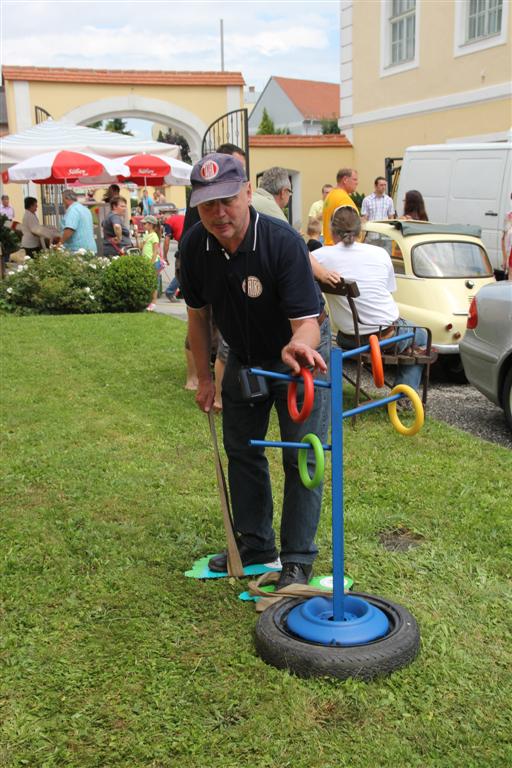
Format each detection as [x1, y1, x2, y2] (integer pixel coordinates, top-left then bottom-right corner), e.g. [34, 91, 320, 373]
[5, 150, 126, 184]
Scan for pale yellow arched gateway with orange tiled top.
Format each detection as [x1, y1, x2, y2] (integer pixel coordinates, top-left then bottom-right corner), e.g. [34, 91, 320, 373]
[3, 65, 244, 161]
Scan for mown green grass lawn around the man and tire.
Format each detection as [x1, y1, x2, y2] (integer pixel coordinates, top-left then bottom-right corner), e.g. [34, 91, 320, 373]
[0, 314, 512, 768]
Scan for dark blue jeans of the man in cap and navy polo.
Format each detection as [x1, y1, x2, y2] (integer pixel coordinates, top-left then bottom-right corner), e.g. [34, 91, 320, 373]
[222, 319, 331, 563]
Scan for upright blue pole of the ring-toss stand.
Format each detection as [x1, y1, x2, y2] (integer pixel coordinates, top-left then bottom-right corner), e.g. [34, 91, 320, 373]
[331, 347, 345, 621]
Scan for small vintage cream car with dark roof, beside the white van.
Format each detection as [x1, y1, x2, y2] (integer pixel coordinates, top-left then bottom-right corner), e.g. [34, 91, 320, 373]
[364, 220, 495, 373]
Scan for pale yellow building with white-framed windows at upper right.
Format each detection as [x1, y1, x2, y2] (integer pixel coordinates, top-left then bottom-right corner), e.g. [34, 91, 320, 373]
[340, 0, 512, 193]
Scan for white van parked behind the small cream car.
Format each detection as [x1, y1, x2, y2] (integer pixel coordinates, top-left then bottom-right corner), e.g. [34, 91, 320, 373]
[395, 141, 512, 268]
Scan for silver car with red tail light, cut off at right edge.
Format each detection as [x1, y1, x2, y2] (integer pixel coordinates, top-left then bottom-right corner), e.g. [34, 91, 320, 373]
[459, 280, 512, 429]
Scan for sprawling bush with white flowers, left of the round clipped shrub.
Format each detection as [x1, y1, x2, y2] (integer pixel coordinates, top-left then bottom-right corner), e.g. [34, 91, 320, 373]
[0, 249, 105, 315]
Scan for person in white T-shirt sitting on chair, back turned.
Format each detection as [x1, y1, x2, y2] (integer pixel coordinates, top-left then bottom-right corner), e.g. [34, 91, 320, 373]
[310, 206, 428, 390]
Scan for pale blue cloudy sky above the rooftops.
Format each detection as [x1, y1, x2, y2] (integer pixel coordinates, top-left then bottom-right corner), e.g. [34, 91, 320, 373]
[0, 0, 339, 90]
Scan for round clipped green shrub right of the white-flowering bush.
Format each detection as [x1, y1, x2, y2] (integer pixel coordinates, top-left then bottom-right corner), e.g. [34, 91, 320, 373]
[102, 255, 157, 312]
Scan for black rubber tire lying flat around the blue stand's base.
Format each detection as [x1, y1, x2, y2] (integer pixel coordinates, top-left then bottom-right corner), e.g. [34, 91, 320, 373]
[255, 592, 420, 681]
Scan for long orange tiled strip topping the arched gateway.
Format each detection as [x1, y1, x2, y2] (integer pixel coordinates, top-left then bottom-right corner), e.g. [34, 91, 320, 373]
[2, 64, 245, 85]
